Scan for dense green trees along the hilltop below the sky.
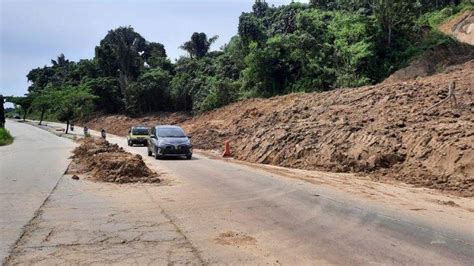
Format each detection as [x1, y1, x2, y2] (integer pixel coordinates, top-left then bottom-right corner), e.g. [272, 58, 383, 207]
[9, 0, 472, 124]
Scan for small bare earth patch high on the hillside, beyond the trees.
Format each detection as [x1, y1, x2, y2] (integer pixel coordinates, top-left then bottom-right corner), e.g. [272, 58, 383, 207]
[439, 11, 474, 45]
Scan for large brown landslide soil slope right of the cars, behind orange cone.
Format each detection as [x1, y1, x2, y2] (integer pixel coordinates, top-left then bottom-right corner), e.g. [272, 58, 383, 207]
[183, 61, 474, 197]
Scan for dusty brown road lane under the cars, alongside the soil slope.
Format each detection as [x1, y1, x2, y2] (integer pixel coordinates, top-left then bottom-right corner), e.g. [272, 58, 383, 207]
[2, 120, 474, 265]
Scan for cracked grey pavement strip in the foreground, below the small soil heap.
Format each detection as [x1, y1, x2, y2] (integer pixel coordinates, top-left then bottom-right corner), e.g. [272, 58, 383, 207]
[6, 175, 202, 265]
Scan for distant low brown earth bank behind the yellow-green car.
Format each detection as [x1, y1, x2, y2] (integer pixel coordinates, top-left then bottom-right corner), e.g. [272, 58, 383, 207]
[80, 112, 191, 136]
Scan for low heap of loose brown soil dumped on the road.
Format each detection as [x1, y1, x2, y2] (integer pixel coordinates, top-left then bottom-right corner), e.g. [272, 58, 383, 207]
[69, 138, 160, 183]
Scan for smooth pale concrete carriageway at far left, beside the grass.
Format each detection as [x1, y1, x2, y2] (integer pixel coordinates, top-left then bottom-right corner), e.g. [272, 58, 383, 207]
[0, 121, 75, 261]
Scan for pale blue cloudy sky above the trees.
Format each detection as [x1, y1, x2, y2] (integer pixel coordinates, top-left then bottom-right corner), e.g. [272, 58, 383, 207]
[0, 0, 310, 98]
